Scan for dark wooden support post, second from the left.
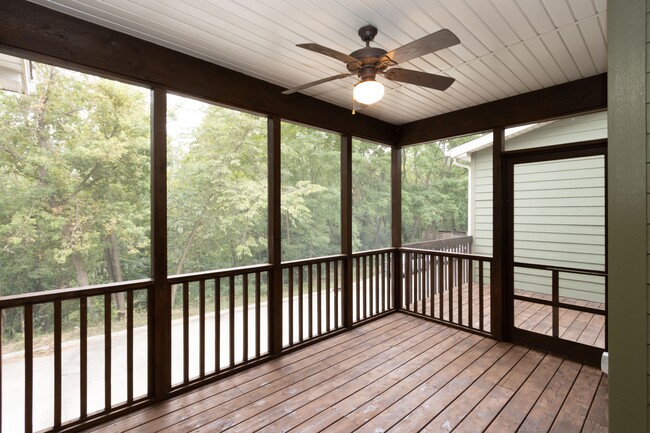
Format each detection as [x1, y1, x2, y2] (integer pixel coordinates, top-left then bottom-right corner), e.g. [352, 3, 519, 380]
[268, 116, 282, 355]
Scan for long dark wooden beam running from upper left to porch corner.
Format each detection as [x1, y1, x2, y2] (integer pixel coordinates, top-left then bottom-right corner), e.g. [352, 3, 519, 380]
[0, 0, 397, 145]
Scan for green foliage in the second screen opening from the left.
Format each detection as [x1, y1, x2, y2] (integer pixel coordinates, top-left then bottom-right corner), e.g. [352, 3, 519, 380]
[167, 97, 268, 274]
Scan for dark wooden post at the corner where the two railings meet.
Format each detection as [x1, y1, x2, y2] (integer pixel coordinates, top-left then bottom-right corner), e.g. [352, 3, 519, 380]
[391, 146, 402, 310]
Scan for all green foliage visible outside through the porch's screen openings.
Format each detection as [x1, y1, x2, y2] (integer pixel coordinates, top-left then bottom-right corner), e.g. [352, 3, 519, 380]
[0, 64, 474, 338]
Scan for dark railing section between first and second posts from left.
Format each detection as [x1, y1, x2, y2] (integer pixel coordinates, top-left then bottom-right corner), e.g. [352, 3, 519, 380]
[167, 265, 272, 387]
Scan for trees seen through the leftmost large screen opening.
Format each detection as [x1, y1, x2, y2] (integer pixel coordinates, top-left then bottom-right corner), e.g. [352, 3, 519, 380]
[0, 64, 150, 330]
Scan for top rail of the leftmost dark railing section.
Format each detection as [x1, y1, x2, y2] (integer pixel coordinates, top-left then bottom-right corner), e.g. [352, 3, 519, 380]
[0, 279, 153, 309]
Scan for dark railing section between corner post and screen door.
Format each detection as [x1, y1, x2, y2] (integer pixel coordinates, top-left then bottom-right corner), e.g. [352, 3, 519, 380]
[399, 248, 492, 334]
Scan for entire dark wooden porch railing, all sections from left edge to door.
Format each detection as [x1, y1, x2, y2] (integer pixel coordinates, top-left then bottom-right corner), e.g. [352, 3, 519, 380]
[0, 248, 490, 432]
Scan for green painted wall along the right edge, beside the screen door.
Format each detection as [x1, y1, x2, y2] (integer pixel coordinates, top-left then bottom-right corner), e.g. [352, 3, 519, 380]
[607, 0, 650, 432]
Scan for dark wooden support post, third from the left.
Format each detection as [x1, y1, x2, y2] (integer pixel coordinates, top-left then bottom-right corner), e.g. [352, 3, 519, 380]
[341, 134, 352, 329]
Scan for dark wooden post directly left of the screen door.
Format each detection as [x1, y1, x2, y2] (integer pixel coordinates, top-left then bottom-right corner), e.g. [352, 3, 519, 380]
[490, 127, 512, 340]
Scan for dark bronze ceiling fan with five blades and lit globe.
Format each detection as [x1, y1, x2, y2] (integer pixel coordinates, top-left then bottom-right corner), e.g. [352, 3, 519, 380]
[282, 25, 460, 105]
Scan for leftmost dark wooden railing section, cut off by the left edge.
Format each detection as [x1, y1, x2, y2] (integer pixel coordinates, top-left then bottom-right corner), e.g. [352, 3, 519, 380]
[0, 280, 155, 432]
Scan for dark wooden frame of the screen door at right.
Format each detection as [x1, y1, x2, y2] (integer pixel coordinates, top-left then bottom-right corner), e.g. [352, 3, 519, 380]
[502, 139, 608, 365]
